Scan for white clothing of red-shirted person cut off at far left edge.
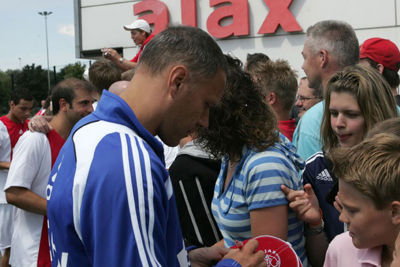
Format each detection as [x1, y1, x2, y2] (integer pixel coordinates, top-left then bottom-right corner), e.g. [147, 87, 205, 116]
[0, 121, 11, 204]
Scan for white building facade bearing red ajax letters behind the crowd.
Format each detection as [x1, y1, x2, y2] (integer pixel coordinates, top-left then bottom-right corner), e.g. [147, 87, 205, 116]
[74, 0, 400, 76]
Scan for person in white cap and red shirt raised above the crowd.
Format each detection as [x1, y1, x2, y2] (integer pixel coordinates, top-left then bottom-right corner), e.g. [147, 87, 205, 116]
[101, 19, 154, 71]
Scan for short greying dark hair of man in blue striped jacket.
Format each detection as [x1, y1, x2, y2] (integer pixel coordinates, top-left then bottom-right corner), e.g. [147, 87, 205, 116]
[138, 26, 226, 78]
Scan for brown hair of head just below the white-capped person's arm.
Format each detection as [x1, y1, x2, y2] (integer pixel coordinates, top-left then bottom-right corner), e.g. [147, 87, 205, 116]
[89, 59, 121, 94]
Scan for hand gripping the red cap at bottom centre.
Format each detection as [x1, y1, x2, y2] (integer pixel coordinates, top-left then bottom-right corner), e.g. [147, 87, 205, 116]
[224, 239, 267, 267]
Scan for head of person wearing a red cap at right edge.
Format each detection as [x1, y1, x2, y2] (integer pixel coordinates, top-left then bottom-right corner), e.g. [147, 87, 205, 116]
[360, 38, 400, 105]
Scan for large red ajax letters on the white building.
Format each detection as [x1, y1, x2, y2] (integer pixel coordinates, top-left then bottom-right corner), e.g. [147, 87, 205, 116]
[133, 0, 302, 38]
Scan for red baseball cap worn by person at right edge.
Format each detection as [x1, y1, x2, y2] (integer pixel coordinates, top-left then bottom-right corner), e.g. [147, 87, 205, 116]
[360, 38, 400, 72]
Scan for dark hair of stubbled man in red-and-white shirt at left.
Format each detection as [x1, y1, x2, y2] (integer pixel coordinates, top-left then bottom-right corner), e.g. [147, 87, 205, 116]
[51, 78, 96, 115]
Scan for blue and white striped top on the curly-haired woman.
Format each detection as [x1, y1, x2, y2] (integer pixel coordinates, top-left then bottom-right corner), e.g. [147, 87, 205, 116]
[211, 135, 308, 266]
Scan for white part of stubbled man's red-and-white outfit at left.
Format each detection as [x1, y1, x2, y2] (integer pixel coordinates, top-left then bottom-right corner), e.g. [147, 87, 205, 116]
[4, 131, 51, 267]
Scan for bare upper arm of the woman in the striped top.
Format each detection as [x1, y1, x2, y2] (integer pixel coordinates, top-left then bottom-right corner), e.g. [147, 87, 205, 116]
[250, 205, 288, 240]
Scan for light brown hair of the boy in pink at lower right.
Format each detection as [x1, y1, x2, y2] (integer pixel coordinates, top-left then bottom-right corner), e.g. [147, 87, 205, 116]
[331, 133, 400, 209]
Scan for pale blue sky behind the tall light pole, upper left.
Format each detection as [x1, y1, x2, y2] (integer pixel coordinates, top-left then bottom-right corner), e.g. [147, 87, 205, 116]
[0, 0, 88, 71]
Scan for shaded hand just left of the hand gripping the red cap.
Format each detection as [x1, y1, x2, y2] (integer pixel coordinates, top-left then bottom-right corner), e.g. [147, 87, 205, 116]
[189, 246, 229, 267]
